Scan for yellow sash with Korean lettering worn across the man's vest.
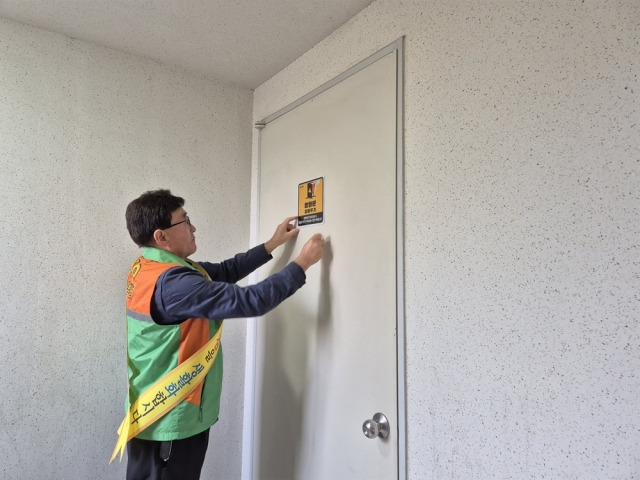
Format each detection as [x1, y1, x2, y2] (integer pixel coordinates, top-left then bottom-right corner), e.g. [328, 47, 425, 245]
[109, 262, 222, 463]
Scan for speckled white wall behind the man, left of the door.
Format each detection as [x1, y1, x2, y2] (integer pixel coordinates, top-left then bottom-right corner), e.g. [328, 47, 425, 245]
[0, 17, 252, 480]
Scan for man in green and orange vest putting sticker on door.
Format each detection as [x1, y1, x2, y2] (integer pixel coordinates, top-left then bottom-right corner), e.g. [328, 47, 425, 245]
[123, 190, 324, 480]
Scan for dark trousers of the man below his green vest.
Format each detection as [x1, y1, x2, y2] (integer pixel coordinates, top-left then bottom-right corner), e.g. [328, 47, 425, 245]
[127, 429, 209, 480]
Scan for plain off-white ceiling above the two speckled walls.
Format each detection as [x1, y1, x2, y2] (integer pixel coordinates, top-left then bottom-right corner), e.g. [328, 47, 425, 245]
[0, 0, 373, 89]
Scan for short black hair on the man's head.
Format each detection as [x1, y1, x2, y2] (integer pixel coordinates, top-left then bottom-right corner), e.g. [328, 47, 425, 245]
[125, 190, 184, 247]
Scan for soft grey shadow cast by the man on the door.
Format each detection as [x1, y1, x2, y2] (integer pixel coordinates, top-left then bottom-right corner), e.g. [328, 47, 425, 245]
[257, 241, 333, 480]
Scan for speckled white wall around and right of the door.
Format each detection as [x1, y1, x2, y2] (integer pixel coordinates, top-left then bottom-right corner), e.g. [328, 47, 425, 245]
[253, 0, 640, 479]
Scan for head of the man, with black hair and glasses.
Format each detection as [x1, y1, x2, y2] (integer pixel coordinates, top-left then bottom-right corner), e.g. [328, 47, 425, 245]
[125, 190, 197, 258]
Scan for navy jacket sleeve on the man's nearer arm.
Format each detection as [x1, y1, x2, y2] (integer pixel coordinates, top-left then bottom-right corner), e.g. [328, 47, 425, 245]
[151, 251, 306, 325]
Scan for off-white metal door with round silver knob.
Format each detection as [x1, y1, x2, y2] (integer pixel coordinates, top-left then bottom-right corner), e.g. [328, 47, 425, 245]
[253, 51, 398, 480]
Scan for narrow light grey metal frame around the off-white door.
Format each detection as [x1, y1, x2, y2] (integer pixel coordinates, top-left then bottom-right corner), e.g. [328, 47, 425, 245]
[242, 37, 407, 480]
